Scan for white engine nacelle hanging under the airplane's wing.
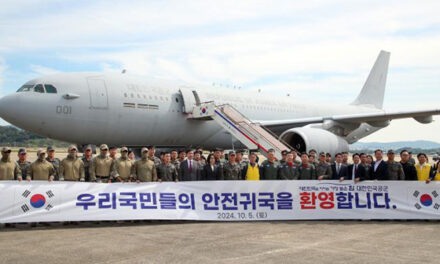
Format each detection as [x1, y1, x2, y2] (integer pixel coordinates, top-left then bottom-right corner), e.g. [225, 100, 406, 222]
[280, 127, 348, 156]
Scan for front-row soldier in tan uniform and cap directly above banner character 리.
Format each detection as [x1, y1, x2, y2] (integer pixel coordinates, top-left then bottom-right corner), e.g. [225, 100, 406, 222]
[89, 144, 114, 183]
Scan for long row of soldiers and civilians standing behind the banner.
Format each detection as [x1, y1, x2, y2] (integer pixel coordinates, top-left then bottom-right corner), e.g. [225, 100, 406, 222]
[0, 144, 440, 183]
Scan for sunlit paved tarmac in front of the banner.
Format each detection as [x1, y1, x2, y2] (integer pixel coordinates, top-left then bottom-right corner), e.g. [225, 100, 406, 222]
[0, 221, 440, 263]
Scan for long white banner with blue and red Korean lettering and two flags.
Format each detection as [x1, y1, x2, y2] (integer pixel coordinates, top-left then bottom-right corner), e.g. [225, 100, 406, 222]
[0, 181, 440, 223]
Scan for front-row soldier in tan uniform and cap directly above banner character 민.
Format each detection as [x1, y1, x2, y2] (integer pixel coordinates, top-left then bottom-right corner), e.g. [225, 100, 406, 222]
[131, 148, 157, 183]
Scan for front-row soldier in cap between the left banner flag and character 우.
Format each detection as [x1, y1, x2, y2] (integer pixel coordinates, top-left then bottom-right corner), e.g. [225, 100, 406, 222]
[59, 145, 85, 182]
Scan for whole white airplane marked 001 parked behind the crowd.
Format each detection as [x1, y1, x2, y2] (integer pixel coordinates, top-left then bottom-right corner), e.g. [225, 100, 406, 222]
[0, 51, 440, 157]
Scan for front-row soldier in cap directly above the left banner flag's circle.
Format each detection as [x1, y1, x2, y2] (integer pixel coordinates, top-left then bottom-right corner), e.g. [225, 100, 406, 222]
[26, 149, 56, 181]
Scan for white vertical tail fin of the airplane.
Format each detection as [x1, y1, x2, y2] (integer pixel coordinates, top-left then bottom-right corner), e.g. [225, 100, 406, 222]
[351, 50, 390, 109]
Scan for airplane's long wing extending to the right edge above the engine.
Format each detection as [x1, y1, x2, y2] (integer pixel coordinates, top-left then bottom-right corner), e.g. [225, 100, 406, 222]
[258, 109, 440, 133]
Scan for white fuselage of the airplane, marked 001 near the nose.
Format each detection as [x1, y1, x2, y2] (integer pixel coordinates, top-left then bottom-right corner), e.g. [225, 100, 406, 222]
[0, 73, 378, 148]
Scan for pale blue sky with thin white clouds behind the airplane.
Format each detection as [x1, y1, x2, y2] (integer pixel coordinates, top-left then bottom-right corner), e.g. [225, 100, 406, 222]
[0, 0, 440, 142]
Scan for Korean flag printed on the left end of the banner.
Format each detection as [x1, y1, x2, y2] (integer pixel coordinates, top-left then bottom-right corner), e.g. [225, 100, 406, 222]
[15, 185, 59, 216]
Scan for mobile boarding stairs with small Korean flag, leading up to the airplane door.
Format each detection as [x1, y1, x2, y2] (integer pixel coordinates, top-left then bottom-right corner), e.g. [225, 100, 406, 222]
[188, 102, 291, 160]
